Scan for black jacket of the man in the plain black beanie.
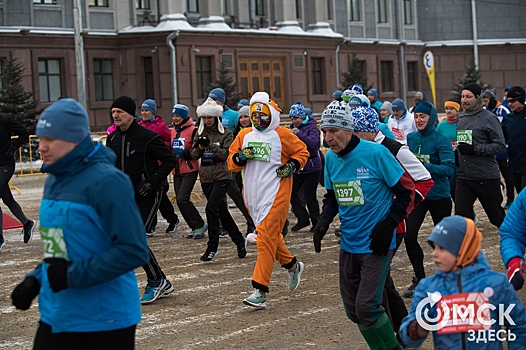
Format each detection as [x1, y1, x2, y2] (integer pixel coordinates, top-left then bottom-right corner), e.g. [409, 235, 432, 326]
[106, 120, 176, 196]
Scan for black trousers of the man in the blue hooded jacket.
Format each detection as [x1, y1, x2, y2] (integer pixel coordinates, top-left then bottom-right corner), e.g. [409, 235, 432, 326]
[33, 321, 136, 350]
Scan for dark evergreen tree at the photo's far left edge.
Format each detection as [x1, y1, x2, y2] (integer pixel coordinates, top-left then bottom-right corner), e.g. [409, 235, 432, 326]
[0, 50, 42, 134]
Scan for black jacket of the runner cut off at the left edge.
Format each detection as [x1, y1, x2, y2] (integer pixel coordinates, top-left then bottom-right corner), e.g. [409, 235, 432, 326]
[0, 114, 29, 166]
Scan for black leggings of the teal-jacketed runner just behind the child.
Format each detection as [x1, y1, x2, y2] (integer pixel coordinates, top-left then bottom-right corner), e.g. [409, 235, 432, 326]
[404, 197, 453, 280]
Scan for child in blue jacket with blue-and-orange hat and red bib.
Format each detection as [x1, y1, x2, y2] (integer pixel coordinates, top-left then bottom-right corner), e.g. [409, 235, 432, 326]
[399, 215, 526, 350]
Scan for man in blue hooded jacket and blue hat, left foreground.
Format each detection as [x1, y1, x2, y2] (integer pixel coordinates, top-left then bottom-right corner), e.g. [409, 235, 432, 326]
[11, 98, 148, 349]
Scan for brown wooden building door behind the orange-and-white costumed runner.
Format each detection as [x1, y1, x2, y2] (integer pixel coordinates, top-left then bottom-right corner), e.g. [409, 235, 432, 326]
[238, 58, 285, 109]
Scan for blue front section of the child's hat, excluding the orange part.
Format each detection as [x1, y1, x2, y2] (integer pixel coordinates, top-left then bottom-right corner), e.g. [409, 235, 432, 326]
[427, 215, 466, 256]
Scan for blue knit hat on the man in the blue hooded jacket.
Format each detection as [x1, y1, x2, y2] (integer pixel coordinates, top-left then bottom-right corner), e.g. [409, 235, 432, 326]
[36, 98, 89, 143]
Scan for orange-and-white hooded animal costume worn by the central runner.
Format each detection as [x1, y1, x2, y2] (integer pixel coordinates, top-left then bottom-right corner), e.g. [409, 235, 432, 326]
[228, 92, 309, 293]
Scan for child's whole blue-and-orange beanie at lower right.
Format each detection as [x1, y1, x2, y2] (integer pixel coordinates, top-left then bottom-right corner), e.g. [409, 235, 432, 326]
[427, 215, 482, 271]
